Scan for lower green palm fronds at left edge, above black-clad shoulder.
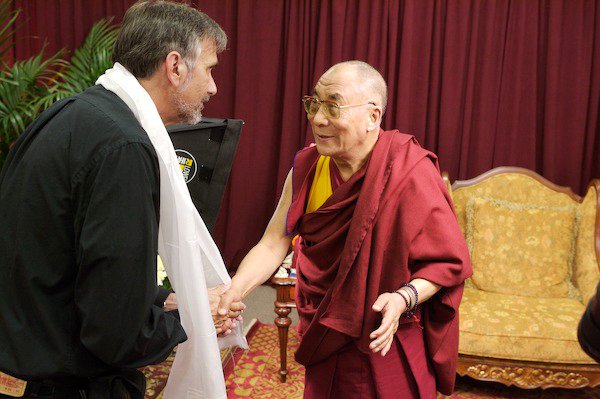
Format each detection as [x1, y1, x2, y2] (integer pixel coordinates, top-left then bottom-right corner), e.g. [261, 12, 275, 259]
[0, 50, 65, 143]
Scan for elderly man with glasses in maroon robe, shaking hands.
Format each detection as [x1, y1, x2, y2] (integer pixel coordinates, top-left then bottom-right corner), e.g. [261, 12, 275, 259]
[219, 61, 471, 399]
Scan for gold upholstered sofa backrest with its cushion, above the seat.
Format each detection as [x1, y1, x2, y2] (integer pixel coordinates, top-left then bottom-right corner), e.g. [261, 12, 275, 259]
[452, 168, 600, 303]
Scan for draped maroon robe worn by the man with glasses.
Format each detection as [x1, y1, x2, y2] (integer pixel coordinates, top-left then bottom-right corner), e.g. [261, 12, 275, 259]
[287, 131, 471, 397]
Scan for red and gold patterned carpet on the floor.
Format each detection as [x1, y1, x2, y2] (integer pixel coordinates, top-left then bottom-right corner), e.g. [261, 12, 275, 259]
[144, 322, 600, 399]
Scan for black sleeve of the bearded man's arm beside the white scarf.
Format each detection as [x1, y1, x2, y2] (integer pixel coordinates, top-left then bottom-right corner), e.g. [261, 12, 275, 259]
[74, 142, 186, 368]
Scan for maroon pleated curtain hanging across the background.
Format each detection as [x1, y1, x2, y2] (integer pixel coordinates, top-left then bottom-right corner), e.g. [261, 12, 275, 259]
[9, 0, 600, 268]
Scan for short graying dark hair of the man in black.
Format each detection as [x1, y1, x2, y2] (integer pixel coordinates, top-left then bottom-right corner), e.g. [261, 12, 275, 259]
[112, 0, 227, 79]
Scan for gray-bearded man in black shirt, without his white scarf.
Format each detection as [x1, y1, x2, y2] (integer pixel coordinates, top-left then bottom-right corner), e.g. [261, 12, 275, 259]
[0, 1, 235, 398]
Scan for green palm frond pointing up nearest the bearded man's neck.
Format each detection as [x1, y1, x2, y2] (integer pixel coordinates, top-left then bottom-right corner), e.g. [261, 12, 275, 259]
[43, 18, 119, 106]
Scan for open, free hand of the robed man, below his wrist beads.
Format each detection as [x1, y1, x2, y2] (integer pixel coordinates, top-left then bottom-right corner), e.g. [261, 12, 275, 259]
[369, 293, 406, 356]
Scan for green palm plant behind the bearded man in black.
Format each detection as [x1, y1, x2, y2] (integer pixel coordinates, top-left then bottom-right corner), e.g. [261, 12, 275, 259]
[0, 0, 118, 168]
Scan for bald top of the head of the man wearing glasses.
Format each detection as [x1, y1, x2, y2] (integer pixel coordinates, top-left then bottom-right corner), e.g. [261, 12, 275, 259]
[322, 60, 387, 112]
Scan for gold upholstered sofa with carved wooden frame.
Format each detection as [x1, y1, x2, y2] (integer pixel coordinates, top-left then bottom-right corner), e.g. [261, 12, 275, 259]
[445, 167, 600, 388]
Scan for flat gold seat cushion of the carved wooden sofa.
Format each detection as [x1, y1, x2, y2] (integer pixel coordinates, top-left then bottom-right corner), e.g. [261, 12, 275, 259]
[459, 288, 595, 364]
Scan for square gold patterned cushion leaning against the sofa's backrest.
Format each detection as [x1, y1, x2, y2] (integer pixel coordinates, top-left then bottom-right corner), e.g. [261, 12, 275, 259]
[466, 197, 580, 299]
